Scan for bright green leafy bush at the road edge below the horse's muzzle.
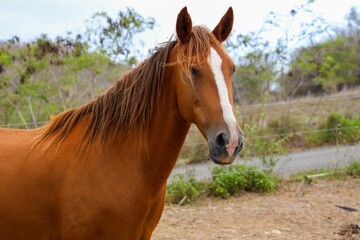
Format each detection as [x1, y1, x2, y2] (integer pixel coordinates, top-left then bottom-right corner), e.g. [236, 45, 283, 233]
[209, 165, 277, 198]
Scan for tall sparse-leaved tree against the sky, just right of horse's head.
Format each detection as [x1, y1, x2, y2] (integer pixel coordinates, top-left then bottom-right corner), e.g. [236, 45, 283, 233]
[229, 0, 328, 103]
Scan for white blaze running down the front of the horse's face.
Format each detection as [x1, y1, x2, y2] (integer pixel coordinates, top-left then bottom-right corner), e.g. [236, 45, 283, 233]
[208, 48, 238, 157]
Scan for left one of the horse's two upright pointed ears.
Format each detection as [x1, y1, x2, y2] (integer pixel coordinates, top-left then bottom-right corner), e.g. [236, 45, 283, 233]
[176, 7, 192, 43]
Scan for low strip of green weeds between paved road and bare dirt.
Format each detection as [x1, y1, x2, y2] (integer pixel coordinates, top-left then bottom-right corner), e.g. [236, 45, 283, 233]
[167, 162, 360, 205]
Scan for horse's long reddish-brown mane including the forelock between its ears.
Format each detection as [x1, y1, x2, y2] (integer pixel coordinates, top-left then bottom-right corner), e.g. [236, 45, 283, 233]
[37, 26, 221, 148]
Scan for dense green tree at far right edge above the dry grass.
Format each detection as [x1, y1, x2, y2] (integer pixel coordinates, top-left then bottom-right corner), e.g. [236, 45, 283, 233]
[283, 8, 360, 95]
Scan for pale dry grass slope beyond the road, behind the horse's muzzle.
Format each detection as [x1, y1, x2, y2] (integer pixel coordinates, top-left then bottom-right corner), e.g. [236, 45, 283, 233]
[179, 88, 360, 163]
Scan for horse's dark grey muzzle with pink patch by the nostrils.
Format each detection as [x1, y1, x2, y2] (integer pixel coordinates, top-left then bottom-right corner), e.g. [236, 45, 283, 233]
[208, 132, 244, 165]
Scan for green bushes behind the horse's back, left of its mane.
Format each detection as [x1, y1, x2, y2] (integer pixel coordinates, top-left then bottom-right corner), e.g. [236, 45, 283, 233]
[0, 35, 124, 128]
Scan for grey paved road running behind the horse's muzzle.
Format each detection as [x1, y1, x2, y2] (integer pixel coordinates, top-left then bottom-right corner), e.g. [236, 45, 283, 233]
[169, 144, 360, 179]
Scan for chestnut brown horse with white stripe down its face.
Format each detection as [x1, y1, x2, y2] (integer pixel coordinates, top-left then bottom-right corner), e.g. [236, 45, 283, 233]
[0, 8, 243, 240]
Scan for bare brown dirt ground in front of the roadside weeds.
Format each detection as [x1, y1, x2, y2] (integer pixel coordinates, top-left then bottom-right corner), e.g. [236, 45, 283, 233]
[152, 178, 360, 240]
